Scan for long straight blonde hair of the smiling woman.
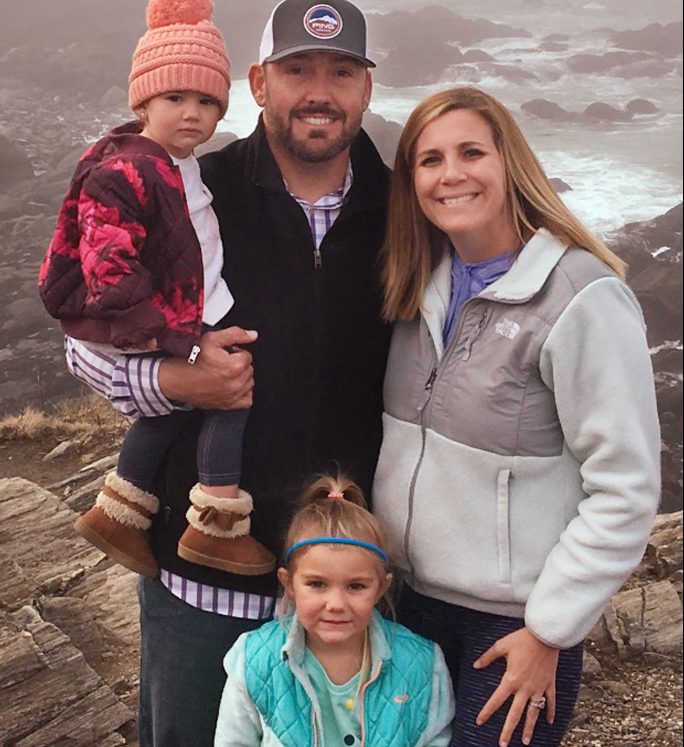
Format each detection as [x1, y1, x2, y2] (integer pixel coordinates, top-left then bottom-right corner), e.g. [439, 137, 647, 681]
[383, 87, 627, 321]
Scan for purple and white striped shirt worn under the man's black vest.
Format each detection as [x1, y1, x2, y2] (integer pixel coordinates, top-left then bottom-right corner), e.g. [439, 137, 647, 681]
[65, 163, 353, 620]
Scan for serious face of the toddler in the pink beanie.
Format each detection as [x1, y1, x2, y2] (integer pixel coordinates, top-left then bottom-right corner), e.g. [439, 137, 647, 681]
[137, 91, 221, 158]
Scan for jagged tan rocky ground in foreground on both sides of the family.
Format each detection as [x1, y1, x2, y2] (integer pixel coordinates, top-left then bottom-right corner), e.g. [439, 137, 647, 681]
[0, 457, 682, 747]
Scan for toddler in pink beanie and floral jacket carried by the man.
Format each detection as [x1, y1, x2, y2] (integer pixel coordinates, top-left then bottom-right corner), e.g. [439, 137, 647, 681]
[39, 0, 275, 576]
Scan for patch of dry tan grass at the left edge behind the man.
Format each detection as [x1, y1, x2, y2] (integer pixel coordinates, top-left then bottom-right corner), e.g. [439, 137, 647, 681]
[0, 394, 128, 441]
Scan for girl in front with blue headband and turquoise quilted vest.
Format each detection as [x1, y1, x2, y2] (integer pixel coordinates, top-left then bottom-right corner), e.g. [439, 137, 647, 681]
[215, 476, 454, 747]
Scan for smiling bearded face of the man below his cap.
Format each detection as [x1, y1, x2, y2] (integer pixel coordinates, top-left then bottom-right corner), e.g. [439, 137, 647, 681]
[250, 52, 371, 163]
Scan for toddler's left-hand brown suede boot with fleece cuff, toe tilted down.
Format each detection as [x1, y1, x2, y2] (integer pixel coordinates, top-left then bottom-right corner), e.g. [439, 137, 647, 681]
[74, 472, 159, 577]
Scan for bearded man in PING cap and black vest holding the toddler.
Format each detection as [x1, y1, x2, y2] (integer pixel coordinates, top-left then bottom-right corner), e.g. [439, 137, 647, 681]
[119, 0, 389, 747]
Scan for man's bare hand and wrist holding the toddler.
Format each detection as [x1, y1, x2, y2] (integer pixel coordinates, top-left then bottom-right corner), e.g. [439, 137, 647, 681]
[159, 327, 257, 410]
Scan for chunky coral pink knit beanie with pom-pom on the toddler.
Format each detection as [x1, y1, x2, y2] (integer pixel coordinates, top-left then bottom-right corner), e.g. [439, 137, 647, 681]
[128, 0, 230, 116]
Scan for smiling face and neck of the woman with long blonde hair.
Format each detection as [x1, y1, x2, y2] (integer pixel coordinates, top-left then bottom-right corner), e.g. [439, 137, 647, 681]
[413, 109, 519, 262]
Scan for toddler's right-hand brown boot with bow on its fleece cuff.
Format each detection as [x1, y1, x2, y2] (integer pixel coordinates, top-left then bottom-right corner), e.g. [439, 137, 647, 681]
[178, 485, 275, 576]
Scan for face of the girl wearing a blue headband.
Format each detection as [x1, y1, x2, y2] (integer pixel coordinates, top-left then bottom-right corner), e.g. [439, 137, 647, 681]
[278, 544, 392, 653]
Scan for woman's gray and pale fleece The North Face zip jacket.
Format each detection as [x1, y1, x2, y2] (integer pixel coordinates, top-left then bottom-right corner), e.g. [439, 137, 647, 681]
[373, 230, 660, 648]
